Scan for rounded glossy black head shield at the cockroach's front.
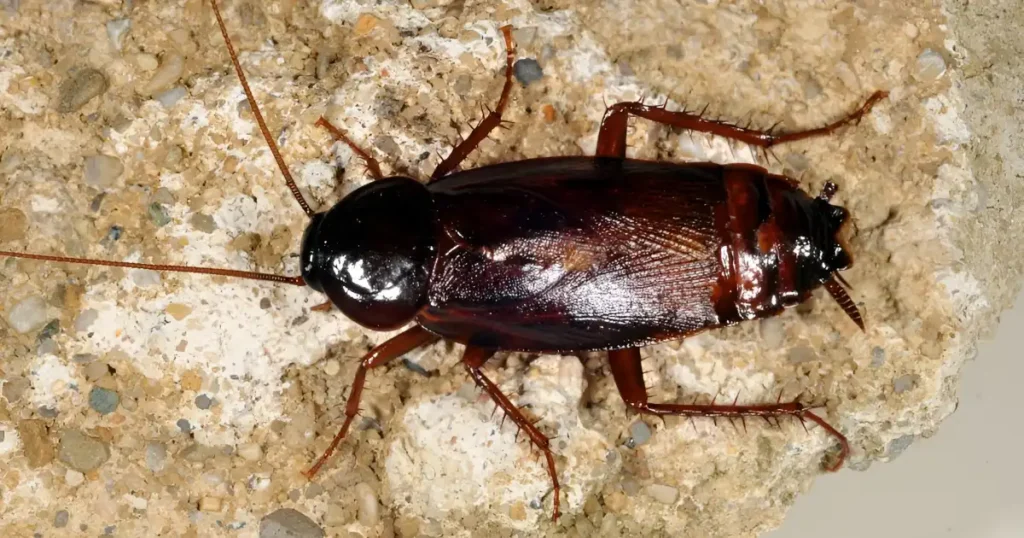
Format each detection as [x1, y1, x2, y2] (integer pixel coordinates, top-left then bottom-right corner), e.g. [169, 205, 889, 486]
[302, 177, 436, 330]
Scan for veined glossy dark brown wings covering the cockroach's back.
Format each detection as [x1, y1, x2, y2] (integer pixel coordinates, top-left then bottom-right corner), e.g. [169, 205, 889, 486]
[418, 158, 726, 351]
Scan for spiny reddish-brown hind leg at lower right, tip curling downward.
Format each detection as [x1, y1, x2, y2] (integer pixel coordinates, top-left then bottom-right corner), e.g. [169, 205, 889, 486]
[608, 347, 850, 471]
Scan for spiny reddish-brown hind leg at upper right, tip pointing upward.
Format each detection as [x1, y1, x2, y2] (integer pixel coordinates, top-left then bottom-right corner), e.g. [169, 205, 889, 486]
[597, 91, 889, 158]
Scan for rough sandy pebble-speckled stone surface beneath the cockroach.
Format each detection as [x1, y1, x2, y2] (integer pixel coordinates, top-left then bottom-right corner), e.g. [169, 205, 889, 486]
[0, 0, 1024, 536]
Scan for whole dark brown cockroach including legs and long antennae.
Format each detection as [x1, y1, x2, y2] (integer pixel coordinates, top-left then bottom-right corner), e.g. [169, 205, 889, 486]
[0, 1, 886, 519]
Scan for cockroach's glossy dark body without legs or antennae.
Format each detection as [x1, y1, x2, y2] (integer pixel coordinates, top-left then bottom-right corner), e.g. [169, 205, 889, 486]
[302, 157, 850, 353]
